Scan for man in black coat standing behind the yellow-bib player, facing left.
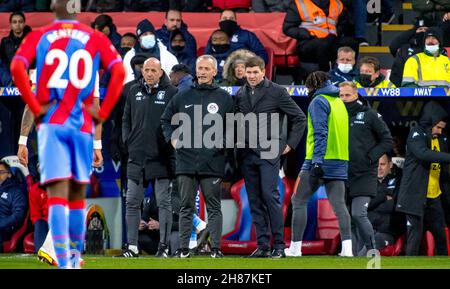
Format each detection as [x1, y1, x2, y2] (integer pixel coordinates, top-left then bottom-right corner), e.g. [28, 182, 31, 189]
[339, 82, 392, 256]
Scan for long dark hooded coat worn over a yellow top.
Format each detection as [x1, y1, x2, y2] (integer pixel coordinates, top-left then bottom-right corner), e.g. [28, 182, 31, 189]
[396, 101, 450, 216]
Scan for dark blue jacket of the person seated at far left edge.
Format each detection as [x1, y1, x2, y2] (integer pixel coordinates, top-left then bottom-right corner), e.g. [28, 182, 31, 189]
[0, 178, 28, 232]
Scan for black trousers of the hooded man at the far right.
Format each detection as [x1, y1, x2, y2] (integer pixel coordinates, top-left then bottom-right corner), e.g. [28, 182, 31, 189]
[406, 197, 448, 256]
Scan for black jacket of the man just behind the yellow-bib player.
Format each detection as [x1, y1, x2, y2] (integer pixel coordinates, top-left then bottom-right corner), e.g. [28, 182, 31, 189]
[345, 100, 392, 198]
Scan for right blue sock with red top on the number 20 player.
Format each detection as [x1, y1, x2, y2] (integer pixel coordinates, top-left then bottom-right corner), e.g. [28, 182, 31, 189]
[69, 200, 86, 268]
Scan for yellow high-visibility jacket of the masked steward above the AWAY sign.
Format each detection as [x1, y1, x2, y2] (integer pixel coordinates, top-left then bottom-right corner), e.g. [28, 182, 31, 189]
[402, 52, 450, 87]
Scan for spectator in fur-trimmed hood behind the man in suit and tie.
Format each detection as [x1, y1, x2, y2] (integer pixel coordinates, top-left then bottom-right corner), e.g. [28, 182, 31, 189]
[221, 49, 256, 86]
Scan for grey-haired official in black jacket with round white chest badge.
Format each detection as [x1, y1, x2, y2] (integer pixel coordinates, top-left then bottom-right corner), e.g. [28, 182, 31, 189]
[161, 55, 233, 258]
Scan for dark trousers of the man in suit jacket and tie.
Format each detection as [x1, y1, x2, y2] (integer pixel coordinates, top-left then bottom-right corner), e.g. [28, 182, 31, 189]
[242, 152, 285, 250]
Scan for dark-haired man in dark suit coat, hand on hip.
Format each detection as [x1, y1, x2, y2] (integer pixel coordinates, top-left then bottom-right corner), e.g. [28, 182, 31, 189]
[235, 56, 306, 258]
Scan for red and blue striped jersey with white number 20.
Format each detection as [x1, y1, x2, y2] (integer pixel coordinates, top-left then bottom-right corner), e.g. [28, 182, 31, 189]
[14, 20, 122, 133]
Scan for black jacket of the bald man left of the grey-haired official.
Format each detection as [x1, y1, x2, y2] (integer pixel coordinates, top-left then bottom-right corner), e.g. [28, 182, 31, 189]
[122, 74, 177, 181]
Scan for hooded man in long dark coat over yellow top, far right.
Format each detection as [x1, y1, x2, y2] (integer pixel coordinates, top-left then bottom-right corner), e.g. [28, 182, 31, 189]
[396, 101, 450, 256]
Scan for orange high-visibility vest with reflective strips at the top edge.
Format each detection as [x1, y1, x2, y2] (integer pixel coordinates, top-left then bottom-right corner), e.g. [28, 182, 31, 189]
[295, 0, 344, 38]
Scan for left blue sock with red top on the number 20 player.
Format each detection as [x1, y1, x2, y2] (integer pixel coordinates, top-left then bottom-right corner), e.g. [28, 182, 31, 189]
[48, 197, 69, 268]
